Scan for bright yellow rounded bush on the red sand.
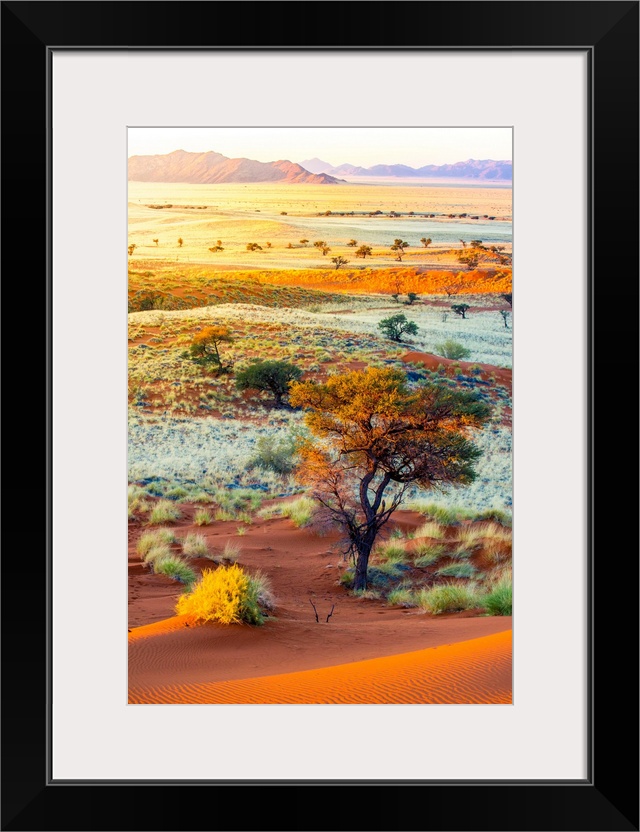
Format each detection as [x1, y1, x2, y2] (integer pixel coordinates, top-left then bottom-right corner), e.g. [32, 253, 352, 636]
[176, 563, 262, 624]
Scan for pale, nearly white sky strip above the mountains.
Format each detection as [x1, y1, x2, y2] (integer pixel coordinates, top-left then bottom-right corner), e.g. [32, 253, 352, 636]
[128, 127, 512, 168]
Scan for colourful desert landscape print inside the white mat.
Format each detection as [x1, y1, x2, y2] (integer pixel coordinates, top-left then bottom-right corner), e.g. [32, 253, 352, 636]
[123, 126, 517, 705]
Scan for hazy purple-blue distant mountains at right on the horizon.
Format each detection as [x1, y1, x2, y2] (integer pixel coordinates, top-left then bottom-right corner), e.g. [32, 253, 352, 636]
[300, 158, 513, 181]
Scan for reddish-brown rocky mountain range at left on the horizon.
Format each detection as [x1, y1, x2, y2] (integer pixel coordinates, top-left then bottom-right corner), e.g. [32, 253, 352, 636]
[129, 150, 340, 185]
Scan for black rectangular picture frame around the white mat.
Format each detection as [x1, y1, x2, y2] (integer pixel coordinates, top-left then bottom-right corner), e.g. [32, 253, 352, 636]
[2, 0, 639, 832]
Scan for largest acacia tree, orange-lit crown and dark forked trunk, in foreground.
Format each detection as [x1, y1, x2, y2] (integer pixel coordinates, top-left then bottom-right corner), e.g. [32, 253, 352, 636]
[289, 367, 490, 590]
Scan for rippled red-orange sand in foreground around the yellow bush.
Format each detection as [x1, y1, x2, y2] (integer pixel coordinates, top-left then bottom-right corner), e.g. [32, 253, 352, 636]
[129, 505, 511, 704]
